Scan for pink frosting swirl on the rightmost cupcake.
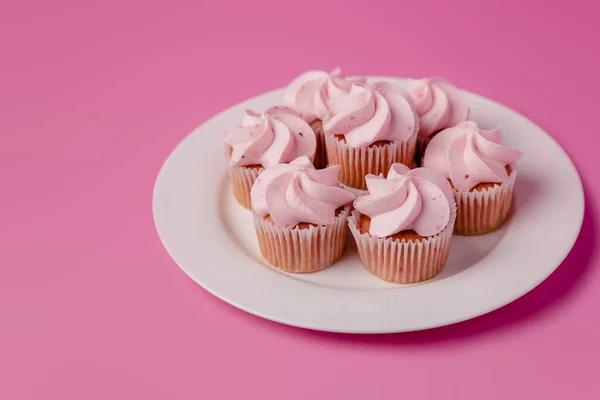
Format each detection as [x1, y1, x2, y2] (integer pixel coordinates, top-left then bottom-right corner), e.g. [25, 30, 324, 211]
[423, 121, 523, 192]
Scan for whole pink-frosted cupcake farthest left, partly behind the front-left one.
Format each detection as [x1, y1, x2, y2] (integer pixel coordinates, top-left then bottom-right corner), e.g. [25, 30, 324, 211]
[223, 107, 317, 209]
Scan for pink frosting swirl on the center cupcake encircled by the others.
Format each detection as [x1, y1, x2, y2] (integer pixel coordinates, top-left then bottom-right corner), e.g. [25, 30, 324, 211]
[323, 82, 419, 148]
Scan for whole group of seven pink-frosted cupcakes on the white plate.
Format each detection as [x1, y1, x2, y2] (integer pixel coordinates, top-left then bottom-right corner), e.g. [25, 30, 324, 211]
[223, 69, 522, 284]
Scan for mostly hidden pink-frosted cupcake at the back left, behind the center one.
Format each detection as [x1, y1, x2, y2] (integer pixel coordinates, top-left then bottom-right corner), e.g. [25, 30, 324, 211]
[284, 68, 366, 168]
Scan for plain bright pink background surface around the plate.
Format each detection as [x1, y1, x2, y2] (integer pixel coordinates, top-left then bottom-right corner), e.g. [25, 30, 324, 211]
[0, 0, 600, 399]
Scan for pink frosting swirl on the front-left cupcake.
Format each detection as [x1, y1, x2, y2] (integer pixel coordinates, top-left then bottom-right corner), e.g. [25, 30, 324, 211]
[250, 157, 356, 228]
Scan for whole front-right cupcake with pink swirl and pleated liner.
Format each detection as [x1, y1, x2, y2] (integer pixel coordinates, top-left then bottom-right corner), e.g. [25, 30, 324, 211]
[348, 164, 456, 283]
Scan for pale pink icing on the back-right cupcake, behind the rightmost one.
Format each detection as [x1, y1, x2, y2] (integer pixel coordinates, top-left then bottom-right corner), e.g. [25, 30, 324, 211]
[408, 78, 469, 137]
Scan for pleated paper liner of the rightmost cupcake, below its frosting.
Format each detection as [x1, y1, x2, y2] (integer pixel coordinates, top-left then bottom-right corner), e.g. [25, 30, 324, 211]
[454, 165, 517, 236]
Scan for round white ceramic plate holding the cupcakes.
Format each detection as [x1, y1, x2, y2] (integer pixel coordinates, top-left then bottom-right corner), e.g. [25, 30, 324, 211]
[153, 78, 584, 333]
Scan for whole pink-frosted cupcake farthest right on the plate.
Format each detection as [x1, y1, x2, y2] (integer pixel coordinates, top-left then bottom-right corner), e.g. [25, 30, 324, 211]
[423, 121, 523, 235]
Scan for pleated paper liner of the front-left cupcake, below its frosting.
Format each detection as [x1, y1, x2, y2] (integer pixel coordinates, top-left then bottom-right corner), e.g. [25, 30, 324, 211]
[253, 206, 350, 273]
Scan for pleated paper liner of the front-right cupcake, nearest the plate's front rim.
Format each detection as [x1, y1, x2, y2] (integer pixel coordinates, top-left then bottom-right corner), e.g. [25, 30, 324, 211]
[348, 206, 456, 283]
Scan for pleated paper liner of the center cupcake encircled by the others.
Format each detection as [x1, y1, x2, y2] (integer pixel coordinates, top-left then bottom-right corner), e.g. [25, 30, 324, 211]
[325, 134, 417, 190]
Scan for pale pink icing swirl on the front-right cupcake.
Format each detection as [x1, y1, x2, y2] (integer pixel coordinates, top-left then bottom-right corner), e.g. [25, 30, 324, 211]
[354, 163, 454, 237]
